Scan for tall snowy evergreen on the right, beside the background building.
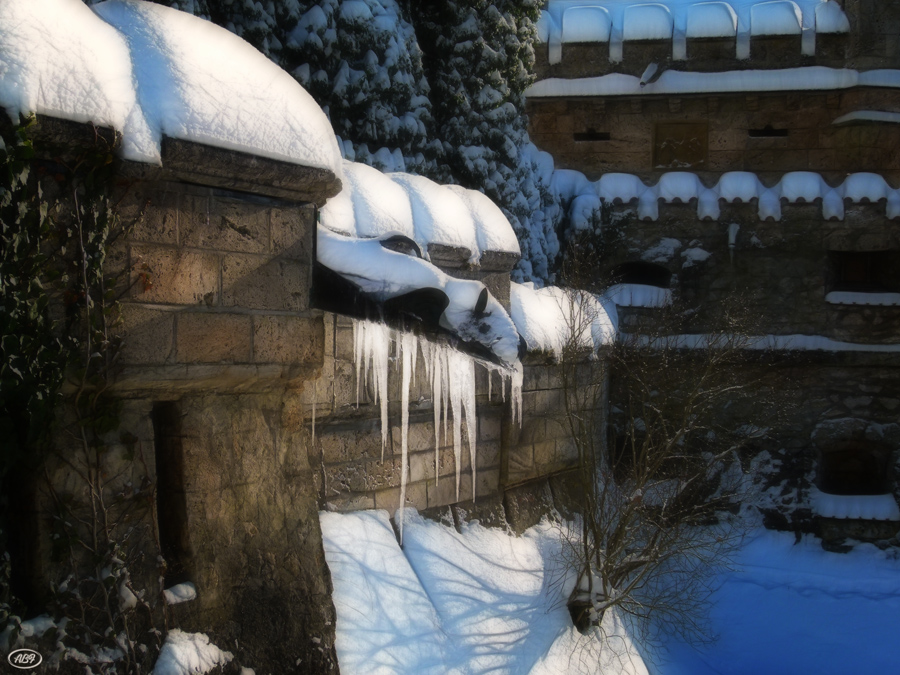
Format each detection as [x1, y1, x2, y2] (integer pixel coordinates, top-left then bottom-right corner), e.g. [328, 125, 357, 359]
[407, 0, 559, 280]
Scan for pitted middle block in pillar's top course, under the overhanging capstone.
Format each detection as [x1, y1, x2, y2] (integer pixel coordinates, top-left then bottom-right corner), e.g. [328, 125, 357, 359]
[179, 195, 269, 253]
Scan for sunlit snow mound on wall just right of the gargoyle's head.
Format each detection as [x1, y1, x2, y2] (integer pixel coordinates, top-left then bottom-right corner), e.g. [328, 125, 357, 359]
[510, 283, 617, 358]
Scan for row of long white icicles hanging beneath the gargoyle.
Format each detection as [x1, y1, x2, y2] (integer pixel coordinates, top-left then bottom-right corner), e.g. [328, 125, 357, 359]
[353, 321, 523, 543]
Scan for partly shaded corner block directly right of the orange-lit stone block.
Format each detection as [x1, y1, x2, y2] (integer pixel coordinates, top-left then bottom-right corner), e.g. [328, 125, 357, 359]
[222, 253, 312, 312]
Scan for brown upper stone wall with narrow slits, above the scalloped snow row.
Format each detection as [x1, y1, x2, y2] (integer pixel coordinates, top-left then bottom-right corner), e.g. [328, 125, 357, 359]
[527, 88, 900, 183]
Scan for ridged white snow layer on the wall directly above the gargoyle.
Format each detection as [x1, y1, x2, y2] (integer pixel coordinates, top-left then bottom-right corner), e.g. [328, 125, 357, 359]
[321, 162, 521, 263]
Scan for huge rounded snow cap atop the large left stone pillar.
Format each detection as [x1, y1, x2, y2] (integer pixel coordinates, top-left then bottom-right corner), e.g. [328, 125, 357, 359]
[0, 0, 340, 176]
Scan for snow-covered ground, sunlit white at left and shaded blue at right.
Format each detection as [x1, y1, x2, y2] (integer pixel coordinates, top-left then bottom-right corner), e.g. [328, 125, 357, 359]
[321, 511, 900, 675]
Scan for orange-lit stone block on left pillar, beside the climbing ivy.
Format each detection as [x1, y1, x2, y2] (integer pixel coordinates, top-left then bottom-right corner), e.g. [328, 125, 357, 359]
[130, 244, 219, 307]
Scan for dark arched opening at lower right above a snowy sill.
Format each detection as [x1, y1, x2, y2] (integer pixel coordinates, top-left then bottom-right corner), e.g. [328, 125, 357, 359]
[819, 444, 890, 495]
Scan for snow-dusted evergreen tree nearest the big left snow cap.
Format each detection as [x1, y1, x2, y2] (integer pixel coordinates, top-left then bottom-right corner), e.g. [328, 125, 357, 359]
[281, 0, 441, 175]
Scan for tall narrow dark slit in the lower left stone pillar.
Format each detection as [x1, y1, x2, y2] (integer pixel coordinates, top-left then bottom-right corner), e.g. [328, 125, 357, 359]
[151, 401, 190, 586]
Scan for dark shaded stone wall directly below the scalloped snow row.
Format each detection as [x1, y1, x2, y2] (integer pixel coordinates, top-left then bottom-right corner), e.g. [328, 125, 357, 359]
[597, 201, 900, 344]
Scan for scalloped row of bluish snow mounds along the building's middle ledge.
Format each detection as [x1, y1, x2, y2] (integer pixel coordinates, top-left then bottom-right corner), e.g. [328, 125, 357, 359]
[554, 171, 900, 228]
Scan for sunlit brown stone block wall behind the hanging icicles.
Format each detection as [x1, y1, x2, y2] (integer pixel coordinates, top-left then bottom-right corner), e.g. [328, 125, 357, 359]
[304, 314, 577, 515]
